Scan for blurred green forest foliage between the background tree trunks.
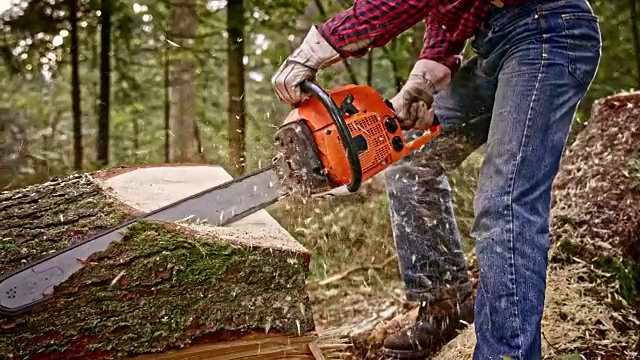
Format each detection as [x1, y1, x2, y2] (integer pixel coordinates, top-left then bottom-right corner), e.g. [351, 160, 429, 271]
[0, 0, 640, 184]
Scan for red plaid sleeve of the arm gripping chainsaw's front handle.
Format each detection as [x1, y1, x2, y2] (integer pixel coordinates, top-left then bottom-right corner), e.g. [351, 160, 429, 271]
[318, 0, 434, 58]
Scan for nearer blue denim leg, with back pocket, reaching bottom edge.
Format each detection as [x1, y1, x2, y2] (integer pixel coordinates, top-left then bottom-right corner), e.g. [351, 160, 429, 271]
[472, 0, 600, 360]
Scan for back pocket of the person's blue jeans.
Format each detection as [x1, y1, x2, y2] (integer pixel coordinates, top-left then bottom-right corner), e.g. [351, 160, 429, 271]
[560, 13, 602, 87]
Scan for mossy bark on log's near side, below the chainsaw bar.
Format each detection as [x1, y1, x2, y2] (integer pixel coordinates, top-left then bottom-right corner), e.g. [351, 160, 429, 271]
[0, 222, 313, 359]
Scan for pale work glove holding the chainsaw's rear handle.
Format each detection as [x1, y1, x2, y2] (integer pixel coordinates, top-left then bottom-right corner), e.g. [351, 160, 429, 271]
[391, 59, 451, 130]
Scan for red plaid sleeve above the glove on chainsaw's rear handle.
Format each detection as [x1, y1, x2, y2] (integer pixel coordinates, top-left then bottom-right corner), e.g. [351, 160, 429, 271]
[418, 15, 466, 74]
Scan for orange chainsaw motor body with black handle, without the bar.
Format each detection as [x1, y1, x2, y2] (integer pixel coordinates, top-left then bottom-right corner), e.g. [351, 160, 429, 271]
[276, 81, 440, 193]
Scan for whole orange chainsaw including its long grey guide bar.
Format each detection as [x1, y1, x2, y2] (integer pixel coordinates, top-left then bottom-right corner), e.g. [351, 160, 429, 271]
[0, 81, 441, 316]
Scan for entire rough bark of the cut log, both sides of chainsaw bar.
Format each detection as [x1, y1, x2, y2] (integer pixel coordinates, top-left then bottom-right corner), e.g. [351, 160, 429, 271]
[0, 172, 314, 359]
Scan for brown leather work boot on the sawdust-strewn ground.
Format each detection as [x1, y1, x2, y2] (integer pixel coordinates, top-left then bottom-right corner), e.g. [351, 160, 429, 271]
[382, 296, 475, 359]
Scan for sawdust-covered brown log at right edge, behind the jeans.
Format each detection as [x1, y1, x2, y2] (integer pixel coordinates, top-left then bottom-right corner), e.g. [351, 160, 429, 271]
[552, 92, 640, 259]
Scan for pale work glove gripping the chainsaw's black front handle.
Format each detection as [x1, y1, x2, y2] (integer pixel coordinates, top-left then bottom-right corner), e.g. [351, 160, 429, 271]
[271, 26, 341, 105]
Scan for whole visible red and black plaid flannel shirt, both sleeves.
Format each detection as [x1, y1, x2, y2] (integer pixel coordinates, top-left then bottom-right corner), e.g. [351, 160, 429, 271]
[318, 0, 527, 73]
